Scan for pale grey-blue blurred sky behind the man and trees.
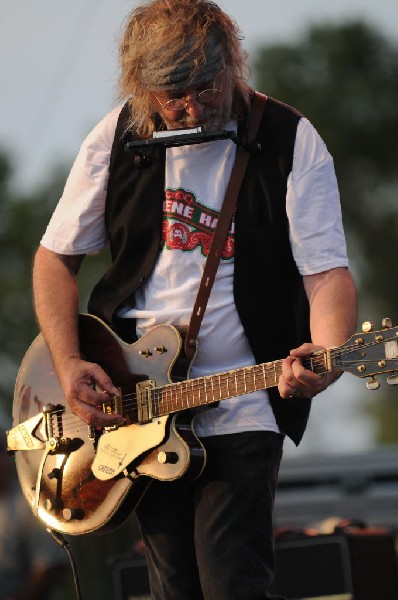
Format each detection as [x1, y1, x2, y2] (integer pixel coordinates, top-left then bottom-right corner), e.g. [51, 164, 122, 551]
[0, 0, 398, 454]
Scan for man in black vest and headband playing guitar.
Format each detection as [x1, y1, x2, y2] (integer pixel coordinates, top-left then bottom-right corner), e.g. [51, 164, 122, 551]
[34, 0, 356, 600]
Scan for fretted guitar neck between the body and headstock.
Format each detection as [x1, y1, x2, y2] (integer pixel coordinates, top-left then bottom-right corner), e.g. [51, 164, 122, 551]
[152, 350, 330, 416]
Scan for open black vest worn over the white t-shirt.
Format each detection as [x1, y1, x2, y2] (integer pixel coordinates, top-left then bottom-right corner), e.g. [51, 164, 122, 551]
[89, 98, 311, 444]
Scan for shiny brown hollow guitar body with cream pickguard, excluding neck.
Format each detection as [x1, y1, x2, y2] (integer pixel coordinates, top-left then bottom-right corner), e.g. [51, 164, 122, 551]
[9, 315, 205, 535]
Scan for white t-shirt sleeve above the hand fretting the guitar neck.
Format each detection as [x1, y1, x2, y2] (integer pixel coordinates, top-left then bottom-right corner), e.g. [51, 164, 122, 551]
[286, 118, 348, 275]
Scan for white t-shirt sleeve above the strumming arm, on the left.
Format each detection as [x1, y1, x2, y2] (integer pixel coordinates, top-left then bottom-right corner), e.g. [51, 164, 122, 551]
[41, 106, 121, 255]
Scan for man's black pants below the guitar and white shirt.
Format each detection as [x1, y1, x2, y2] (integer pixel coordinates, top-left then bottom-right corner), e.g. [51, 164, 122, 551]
[137, 432, 283, 600]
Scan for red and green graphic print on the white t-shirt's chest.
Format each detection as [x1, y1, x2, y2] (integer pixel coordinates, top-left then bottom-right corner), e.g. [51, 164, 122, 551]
[162, 188, 235, 260]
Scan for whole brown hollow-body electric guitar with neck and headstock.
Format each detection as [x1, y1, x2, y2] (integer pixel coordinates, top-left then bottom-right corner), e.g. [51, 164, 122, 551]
[7, 315, 398, 535]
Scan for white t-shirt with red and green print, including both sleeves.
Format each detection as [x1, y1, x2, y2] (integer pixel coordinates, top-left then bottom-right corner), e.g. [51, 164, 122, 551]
[41, 107, 348, 436]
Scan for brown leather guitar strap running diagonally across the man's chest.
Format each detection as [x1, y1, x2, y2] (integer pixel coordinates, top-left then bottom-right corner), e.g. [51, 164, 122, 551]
[184, 92, 267, 360]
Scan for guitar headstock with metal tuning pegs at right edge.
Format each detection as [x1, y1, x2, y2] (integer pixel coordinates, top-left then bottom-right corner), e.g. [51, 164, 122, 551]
[330, 318, 398, 390]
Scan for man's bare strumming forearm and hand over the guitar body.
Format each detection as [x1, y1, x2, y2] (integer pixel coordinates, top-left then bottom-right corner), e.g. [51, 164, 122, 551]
[33, 247, 124, 427]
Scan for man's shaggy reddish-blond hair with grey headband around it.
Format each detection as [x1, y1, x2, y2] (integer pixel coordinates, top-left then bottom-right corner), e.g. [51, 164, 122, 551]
[119, 0, 250, 138]
